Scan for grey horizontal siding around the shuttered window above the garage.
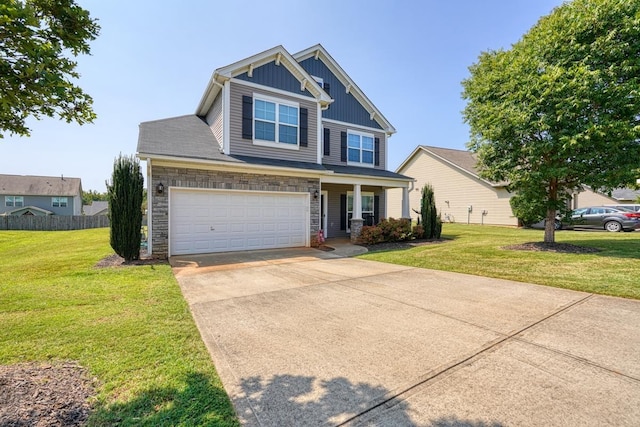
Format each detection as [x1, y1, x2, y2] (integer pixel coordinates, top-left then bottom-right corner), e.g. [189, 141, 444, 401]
[229, 82, 318, 163]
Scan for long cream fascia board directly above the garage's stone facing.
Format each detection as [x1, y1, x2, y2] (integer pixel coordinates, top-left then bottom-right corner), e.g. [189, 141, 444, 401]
[140, 153, 326, 178]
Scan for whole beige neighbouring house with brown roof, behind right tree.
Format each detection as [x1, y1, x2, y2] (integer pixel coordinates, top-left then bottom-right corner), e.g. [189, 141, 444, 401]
[387, 145, 518, 226]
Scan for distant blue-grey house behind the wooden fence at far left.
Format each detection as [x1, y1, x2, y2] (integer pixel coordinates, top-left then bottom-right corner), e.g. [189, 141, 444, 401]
[0, 175, 82, 215]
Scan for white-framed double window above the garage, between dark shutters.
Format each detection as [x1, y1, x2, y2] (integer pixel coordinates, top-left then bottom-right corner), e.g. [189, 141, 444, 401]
[253, 97, 300, 148]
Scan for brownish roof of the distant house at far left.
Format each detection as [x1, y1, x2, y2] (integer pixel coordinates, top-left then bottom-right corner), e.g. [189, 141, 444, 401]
[0, 175, 82, 197]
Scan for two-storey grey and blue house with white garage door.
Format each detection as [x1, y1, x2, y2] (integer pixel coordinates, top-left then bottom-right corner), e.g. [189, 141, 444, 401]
[138, 45, 412, 256]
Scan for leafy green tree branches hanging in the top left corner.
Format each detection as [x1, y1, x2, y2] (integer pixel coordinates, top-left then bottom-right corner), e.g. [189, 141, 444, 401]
[0, 0, 100, 138]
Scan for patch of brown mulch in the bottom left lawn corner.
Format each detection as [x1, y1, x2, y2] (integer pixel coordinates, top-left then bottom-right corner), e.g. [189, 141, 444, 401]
[0, 362, 97, 427]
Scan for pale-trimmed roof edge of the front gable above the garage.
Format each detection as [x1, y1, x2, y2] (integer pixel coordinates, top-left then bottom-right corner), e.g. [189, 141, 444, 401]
[196, 45, 333, 116]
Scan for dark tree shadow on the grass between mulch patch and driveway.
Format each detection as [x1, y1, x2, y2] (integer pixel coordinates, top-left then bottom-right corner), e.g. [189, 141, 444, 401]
[88, 373, 239, 426]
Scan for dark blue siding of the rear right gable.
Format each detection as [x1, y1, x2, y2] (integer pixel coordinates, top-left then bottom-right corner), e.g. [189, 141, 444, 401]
[298, 57, 382, 129]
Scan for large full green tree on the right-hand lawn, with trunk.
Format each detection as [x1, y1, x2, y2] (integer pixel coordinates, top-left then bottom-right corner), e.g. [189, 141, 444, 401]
[462, 0, 640, 242]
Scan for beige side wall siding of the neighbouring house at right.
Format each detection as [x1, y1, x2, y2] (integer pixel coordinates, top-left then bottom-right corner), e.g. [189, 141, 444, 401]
[387, 151, 518, 226]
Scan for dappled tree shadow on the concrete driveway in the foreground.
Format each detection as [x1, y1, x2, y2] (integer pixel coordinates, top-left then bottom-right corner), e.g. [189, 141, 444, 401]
[236, 374, 502, 427]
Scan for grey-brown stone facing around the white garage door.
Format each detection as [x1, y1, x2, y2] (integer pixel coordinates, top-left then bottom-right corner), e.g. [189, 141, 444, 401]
[148, 166, 320, 257]
